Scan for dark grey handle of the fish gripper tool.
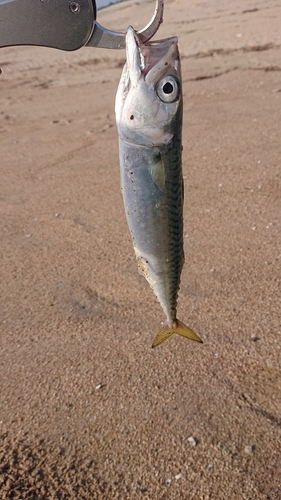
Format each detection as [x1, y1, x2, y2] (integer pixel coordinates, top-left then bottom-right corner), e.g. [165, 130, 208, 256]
[0, 0, 96, 50]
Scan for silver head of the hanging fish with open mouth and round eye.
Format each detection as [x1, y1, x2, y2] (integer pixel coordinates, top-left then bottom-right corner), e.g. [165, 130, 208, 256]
[115, 27, 182, 147]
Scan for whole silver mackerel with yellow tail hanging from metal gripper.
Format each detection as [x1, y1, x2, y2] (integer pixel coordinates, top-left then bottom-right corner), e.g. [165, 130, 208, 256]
[115, 26, 202, 347]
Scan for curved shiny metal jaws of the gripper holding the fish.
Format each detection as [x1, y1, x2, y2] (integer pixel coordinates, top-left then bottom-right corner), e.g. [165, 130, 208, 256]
[86, 0, 164, 49]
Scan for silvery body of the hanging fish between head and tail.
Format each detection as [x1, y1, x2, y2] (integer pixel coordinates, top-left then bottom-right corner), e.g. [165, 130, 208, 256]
[119, 112, 184, 321]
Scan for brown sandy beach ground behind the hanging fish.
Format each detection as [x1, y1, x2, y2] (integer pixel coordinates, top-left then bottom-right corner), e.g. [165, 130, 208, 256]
[0, 0, 281, 500]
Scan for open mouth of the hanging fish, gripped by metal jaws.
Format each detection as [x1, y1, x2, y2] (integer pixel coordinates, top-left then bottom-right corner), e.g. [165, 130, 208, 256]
[126, 26, 179, 87]
